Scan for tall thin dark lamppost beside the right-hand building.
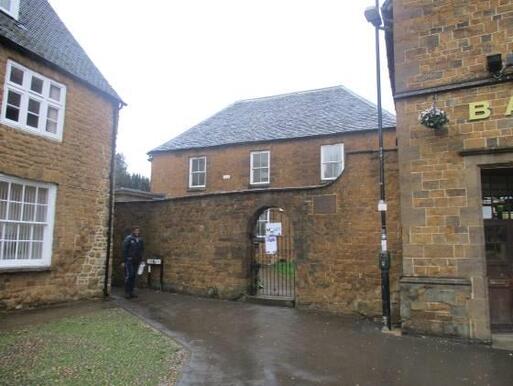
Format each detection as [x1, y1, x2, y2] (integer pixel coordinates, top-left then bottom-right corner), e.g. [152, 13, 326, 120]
[365, 0, 392, 330]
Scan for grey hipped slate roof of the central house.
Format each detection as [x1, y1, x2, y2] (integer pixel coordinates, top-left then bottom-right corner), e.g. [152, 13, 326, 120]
[148, 86, 395, 154]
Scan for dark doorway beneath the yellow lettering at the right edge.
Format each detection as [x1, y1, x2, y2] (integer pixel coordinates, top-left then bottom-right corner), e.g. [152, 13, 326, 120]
[481, 168, 513, 332]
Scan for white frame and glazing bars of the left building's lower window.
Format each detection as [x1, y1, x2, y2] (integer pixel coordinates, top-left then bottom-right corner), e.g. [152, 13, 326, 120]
[0, 174, 57, 271]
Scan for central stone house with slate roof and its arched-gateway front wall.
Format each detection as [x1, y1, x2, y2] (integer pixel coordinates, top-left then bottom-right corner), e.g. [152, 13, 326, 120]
[115, 87, 401, 315]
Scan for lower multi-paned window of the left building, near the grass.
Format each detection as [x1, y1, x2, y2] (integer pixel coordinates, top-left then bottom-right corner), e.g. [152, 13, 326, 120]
[0, 174, 56, 268]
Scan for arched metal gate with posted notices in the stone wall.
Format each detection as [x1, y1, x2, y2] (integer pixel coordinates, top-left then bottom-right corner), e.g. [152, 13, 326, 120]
[250, 208, 296, 300]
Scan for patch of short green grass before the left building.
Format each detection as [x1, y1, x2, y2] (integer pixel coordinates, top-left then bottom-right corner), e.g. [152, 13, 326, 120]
[0, 309, 184, 385]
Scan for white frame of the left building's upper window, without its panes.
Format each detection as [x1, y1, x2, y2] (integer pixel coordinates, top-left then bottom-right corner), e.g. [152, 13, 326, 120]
[0, 60, 66, 142]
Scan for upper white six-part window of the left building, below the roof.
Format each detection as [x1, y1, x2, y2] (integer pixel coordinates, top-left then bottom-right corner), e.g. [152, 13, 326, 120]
[2, 61, 65, 140]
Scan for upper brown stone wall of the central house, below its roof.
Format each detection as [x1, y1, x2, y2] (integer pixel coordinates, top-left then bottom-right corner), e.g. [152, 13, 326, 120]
[151, 130, 395, 197]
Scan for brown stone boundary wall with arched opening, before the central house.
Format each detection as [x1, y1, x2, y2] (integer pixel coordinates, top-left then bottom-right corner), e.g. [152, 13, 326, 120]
[114, 148, 402, 316]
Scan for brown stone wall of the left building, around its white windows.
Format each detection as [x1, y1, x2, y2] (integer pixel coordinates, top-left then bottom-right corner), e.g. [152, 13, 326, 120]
[0, 46, 117, 309]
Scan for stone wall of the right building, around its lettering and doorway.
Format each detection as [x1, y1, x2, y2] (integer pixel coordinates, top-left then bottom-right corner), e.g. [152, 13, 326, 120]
[393, 0, 513, 341]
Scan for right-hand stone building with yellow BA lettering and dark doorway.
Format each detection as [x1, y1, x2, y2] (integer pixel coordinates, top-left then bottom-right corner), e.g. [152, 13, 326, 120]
[383, 0, 513, 341]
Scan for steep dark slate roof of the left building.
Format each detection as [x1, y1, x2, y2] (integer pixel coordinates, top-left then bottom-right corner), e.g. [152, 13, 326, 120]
[0, 0, 122, 102]
